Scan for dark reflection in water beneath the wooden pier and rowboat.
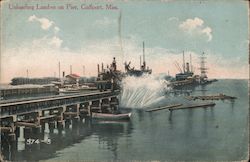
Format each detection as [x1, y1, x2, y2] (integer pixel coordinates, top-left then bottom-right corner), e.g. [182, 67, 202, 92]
[2, 119, 132, 161]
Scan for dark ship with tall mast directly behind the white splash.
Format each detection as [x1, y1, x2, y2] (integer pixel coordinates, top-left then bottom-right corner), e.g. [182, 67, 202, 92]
[124, 42, 152, 77]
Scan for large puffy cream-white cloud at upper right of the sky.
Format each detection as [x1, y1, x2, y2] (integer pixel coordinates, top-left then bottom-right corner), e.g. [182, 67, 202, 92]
[179, 17, 213, 42]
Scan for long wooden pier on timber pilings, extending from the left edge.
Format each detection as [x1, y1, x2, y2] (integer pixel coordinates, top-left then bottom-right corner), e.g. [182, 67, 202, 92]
[0, 91, 120, 141]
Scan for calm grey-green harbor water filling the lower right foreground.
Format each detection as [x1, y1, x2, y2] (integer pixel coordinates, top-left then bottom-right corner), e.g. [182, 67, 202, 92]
[1, 80, 249, 161]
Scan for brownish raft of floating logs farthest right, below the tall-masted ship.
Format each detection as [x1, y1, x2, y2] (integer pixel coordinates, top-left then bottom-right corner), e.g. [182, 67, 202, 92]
[186, 94, 237, 100]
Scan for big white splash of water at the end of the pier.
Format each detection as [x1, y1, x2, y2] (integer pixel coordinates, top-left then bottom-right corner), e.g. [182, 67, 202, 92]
[120, 75, 169, 108]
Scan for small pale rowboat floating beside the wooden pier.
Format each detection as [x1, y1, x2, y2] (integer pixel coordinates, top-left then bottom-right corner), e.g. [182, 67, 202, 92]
[92, 113, 131, 120]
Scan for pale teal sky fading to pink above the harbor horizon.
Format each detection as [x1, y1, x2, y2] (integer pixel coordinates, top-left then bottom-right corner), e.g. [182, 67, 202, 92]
[0, 0, 249, 83]
